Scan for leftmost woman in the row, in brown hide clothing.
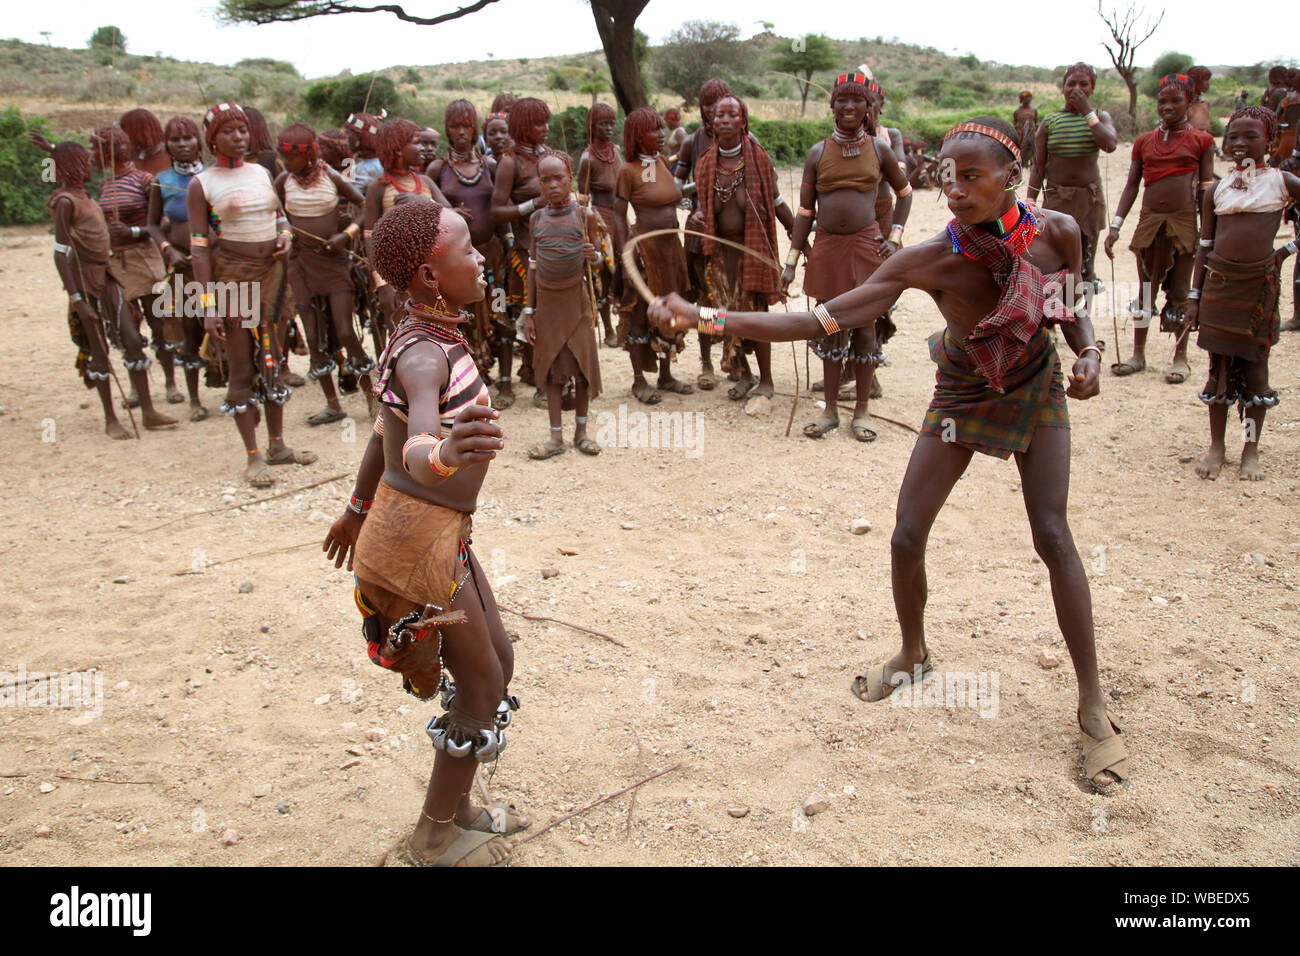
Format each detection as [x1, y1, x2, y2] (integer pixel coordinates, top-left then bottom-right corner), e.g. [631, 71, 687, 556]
[46, 143, 176, 440]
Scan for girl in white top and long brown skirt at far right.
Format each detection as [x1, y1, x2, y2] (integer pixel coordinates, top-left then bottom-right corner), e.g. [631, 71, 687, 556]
[1187, 107, 1300, 481]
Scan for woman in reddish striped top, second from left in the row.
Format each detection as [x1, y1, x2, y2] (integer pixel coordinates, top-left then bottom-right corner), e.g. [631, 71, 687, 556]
[90, 126, 185, 405]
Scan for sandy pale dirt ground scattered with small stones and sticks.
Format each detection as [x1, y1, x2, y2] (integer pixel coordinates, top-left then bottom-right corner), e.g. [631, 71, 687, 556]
[0, 146, 1300, 865]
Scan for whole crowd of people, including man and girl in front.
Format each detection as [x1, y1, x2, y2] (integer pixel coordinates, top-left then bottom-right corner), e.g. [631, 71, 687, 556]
[40, 65, 1300, 865]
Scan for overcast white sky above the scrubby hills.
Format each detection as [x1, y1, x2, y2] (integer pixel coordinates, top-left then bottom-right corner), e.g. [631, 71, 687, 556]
[0, 0, 1300, 77]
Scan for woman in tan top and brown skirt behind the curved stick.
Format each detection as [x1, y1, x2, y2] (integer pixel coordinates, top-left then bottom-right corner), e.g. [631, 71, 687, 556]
[614, 107, 694, 405]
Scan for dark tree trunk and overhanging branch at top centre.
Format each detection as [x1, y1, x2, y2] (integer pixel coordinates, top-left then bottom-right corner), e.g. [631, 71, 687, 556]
[217, 0, 650, 113]
